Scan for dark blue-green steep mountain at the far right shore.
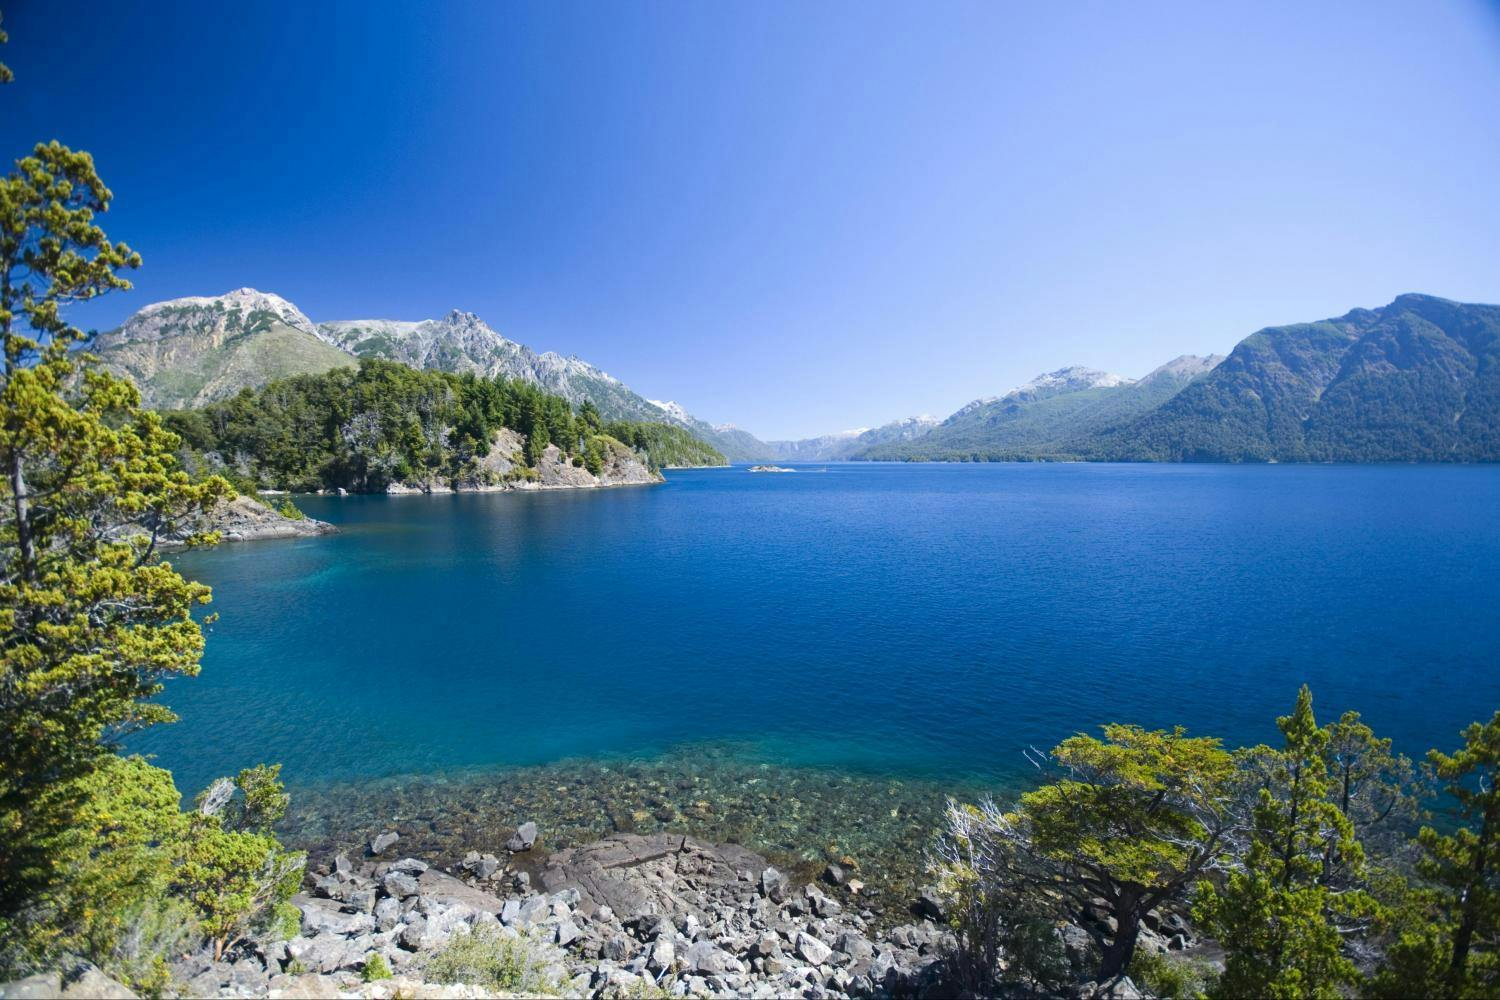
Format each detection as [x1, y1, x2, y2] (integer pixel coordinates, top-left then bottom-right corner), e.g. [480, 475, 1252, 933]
[1079, 295, 1500, 462]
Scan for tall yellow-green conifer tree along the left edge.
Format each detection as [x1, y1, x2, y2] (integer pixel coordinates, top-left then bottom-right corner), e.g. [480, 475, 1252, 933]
[0, 142, 230, 937]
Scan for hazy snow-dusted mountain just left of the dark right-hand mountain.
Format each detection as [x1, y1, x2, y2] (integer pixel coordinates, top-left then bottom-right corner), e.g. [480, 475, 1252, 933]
[854, 355, 1223, 462]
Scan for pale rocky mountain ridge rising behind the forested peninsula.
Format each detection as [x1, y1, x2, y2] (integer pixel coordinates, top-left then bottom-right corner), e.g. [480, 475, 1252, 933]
[93, 288, 770, 462]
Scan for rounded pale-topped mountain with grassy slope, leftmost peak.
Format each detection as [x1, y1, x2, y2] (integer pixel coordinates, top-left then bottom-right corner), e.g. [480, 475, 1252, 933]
[90, 288, 354, 409]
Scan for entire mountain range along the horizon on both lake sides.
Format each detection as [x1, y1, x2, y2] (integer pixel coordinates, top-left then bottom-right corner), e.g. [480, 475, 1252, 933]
[93, 288, 1500, 462]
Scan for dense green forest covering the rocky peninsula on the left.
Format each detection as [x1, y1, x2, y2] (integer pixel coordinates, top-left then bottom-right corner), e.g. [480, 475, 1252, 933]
[164, 358, 725, 493]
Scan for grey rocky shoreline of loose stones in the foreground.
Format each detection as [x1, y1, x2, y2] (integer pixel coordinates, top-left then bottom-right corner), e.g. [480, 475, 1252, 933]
[46, 823, 1187, 1000]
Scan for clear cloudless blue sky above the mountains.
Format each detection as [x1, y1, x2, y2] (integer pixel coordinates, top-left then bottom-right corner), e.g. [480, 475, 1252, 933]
[0, 0, 1500, 438]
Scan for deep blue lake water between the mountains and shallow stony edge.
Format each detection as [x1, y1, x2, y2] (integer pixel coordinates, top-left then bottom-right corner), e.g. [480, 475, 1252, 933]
[135, 465, 1500, 809]
